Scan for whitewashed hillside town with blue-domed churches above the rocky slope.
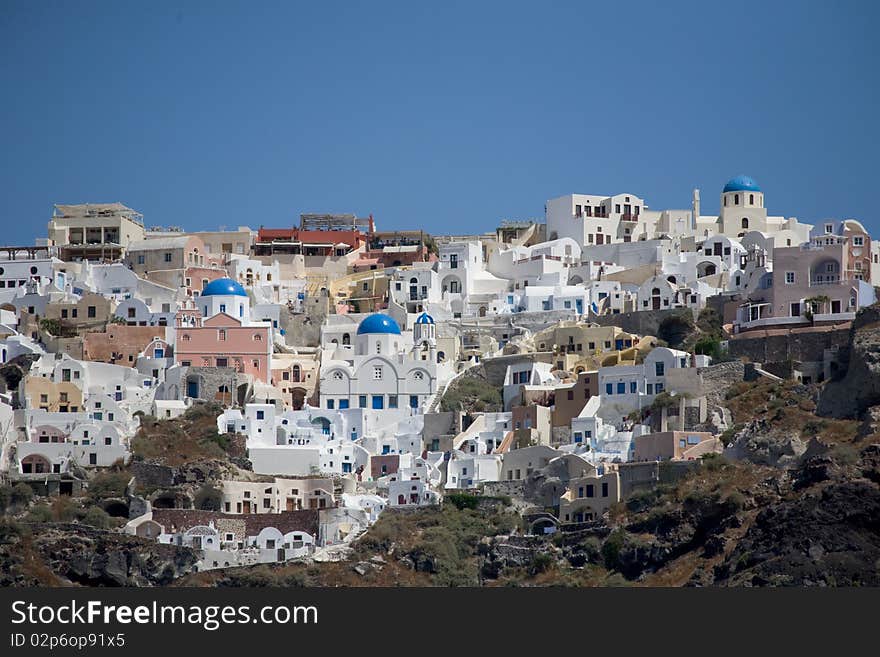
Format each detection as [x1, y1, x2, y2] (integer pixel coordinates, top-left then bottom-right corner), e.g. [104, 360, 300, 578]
[0, 175, 880, 584]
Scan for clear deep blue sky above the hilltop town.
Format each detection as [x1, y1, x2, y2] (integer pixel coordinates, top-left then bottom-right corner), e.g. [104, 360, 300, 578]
[0, 0, 880, 243]
